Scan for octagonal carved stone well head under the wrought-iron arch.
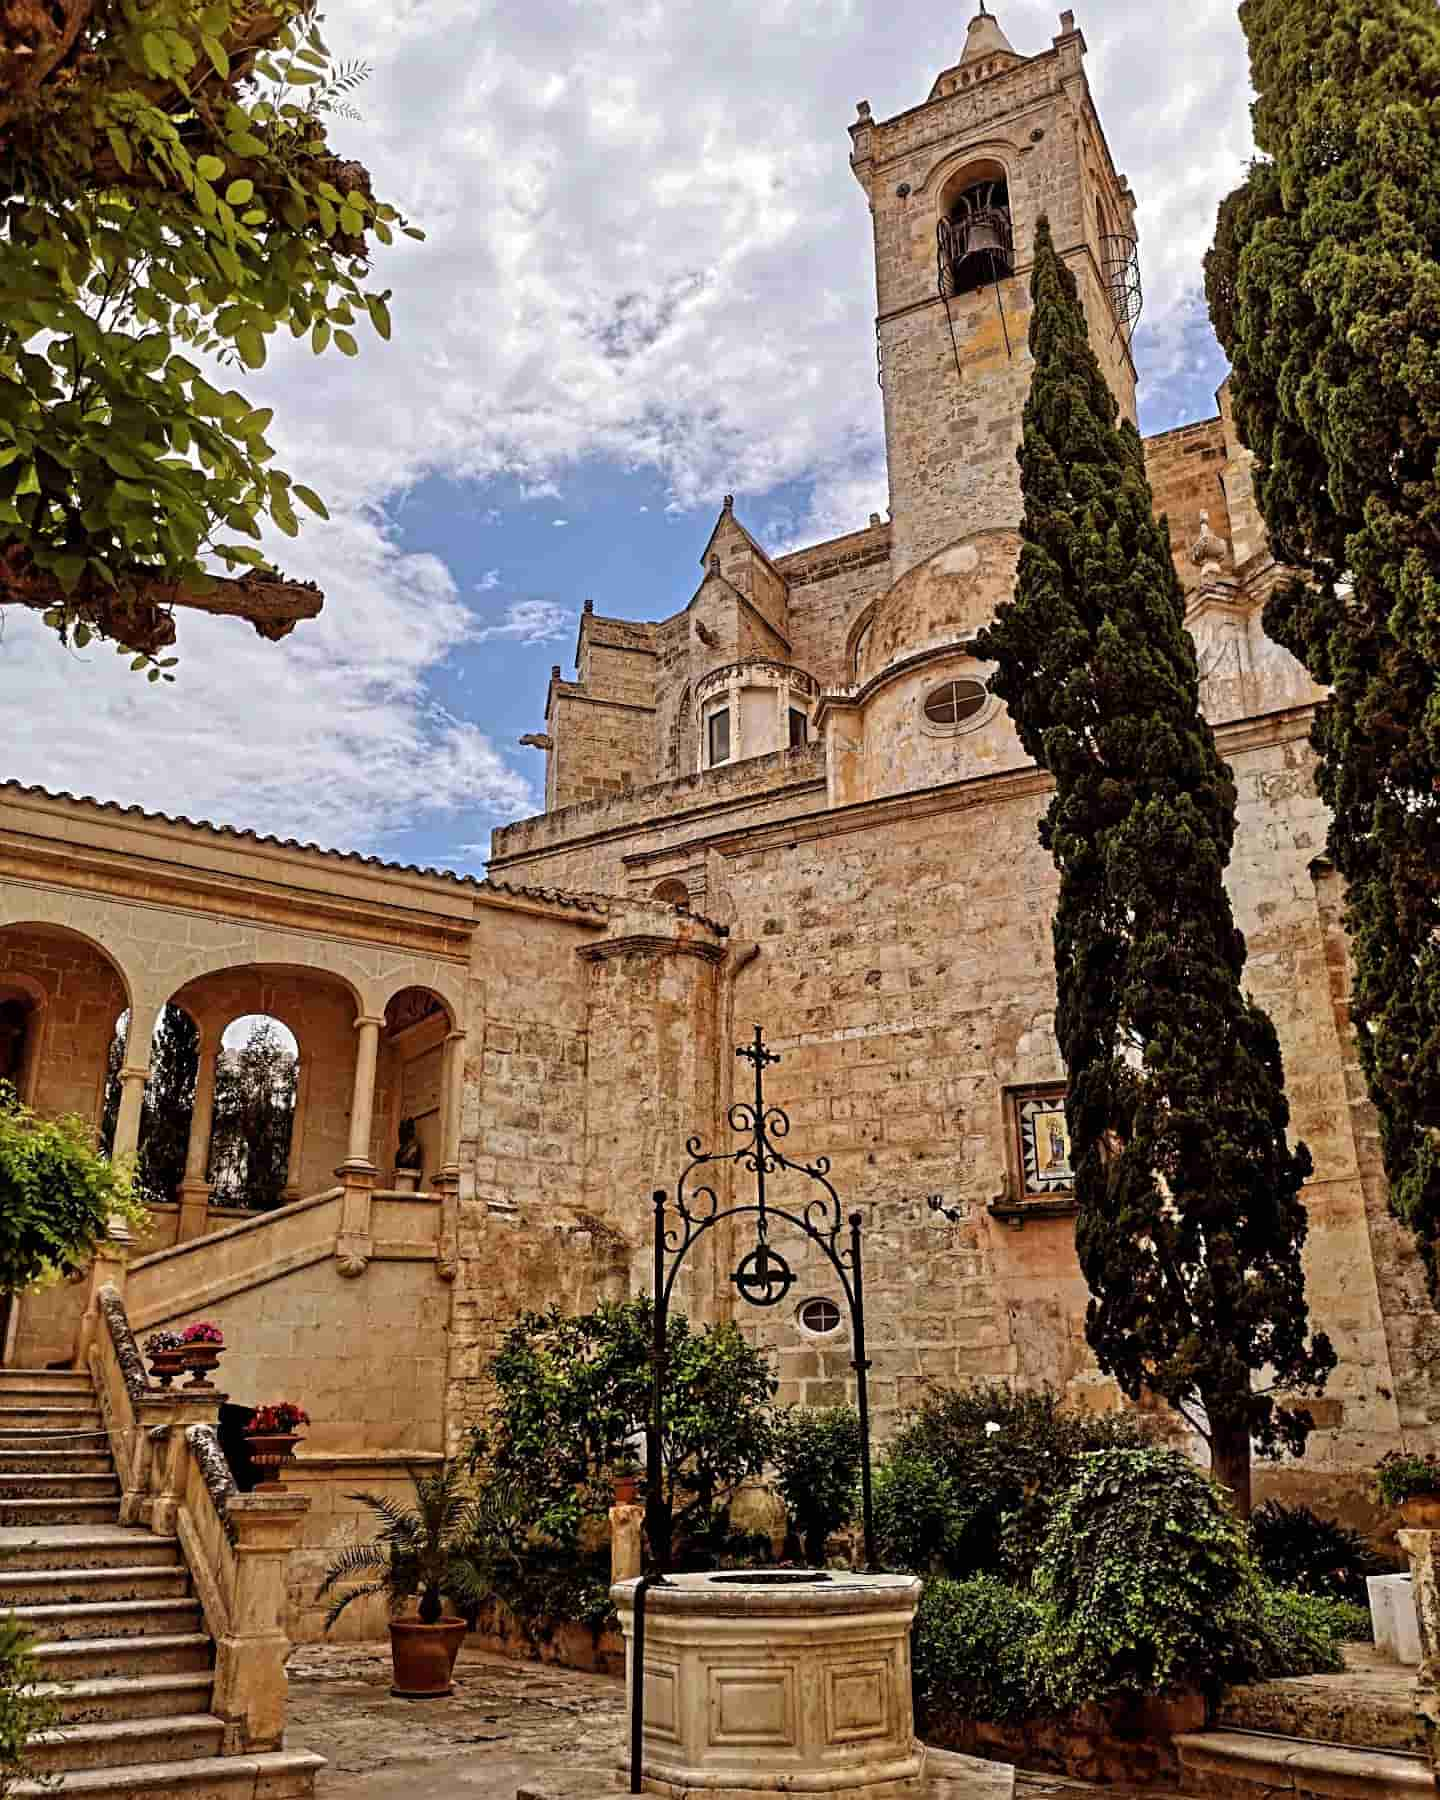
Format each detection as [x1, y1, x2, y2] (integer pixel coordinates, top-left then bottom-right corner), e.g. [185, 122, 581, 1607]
[612, 1570, 923, 1800]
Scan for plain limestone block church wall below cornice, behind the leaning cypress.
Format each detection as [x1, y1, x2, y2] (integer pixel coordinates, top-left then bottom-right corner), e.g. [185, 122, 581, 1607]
[684, 715, 1404, 1510]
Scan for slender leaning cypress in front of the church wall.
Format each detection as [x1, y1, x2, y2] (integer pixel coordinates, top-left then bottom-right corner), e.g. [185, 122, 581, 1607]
[977, 220, 1336, 1512]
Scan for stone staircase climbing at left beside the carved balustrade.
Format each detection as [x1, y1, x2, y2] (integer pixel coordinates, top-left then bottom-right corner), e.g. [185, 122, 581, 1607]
[0, 1370, 324, 1800]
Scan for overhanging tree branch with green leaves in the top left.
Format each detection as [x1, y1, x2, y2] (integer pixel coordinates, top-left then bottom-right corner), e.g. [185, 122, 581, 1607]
[0, 0, 421, 680]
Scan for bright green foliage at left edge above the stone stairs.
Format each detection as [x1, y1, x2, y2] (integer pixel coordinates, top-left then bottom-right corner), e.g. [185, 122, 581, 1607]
[0, 1082, 149, 1294]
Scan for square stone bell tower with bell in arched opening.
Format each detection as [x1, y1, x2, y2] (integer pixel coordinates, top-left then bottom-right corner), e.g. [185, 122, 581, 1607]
[850, 0, 1139, 580]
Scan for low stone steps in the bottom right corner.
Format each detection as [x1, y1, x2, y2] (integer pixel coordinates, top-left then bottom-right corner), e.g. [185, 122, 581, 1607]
[1177, 1645, 1436, 1800]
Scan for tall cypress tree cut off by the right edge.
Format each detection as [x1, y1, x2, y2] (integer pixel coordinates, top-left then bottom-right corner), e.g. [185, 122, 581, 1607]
[1206, 0, 1440, 1298]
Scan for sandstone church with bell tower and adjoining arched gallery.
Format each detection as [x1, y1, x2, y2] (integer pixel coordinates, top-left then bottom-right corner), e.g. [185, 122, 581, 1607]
[0, 7, 1440, 1636]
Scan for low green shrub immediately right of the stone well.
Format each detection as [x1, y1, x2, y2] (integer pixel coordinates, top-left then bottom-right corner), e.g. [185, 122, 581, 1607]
[911, 1575, 1044, 1733]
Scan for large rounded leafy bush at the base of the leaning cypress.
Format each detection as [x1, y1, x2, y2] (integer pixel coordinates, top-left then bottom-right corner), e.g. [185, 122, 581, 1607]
[1031, 1451, 1262, 1710]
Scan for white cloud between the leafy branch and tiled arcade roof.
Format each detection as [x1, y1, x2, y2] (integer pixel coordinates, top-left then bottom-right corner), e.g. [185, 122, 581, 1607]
[0, 517, 535, 851]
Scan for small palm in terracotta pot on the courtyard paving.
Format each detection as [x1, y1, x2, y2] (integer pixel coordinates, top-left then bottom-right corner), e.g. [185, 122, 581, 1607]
[320, 1462, 473, 1699]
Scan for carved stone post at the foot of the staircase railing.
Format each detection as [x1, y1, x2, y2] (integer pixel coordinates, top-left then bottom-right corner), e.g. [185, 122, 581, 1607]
[211, 1494, 310, 1755]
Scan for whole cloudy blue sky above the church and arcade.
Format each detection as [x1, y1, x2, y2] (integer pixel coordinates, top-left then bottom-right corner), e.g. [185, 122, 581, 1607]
[0, 0, 1249, 871]
